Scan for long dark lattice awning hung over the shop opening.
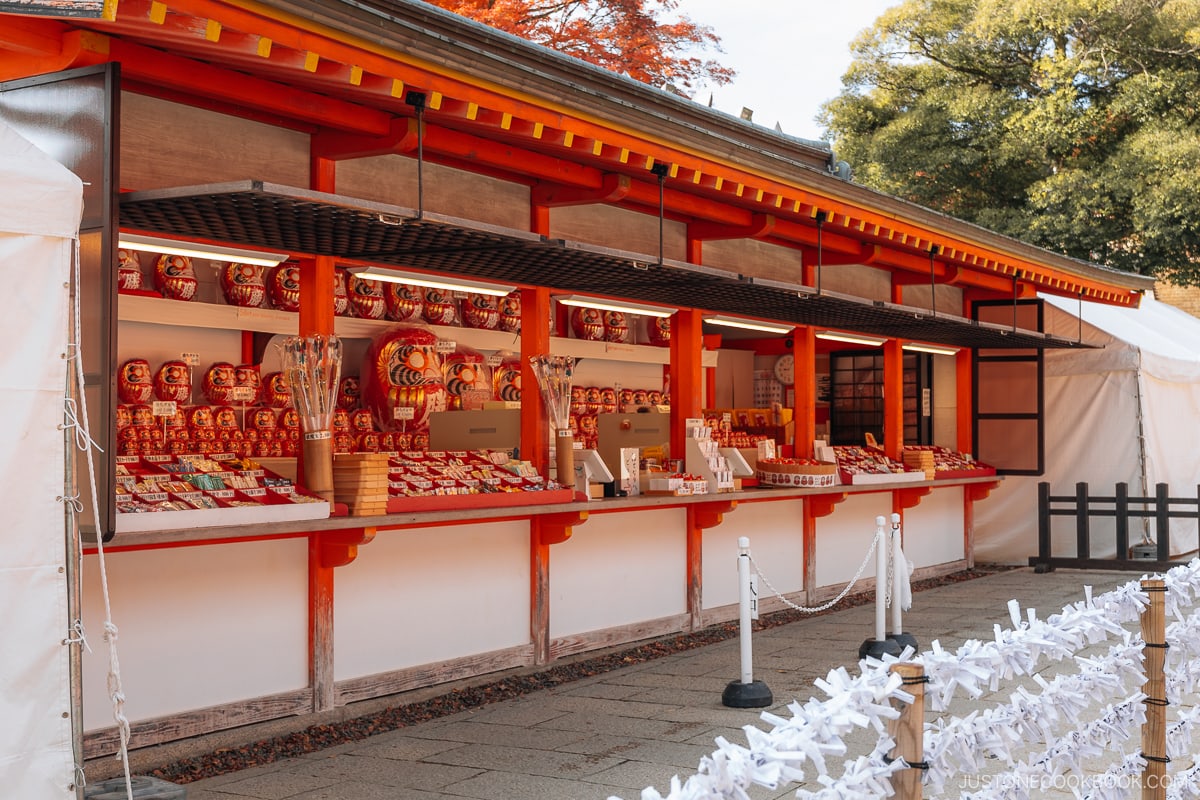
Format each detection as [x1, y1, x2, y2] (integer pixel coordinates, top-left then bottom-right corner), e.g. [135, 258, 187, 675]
[119, 181, 1087, 349]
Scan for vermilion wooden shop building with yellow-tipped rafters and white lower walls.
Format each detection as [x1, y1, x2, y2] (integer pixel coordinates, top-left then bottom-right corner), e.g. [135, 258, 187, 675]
[0, 0, 1152, 757]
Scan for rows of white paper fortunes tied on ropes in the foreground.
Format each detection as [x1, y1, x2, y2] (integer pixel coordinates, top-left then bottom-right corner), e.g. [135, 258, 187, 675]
[613, 559, 1200, 800]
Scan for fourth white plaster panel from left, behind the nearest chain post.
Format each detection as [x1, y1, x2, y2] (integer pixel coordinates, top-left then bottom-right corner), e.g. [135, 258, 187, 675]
[701, 500, 804, 608]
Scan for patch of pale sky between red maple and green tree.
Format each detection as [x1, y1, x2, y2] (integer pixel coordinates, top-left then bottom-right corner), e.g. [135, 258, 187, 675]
[677, 0, 900, 139]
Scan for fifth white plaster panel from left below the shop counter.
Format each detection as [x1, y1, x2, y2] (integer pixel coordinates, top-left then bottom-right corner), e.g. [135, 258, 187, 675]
[815, 492, 892, 588]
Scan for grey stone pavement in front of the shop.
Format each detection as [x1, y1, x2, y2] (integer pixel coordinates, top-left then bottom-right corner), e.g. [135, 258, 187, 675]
[175, 569, 1140, 800]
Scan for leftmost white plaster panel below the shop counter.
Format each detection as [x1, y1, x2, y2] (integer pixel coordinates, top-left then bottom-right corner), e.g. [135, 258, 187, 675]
[83, 539, 308, 730]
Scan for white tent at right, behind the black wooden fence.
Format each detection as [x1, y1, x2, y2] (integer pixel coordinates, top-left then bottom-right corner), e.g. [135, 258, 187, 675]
[976, 295, 1200, 564]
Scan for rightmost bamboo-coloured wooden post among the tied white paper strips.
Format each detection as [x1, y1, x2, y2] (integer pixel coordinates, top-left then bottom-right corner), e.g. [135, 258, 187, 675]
[1141, 578, 1171, 800]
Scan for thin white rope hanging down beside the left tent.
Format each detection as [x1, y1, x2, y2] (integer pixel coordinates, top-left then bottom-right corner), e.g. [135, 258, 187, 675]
[64, 239, 133, 798]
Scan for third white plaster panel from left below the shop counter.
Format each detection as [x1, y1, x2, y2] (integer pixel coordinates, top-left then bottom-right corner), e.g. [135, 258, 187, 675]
[550, 509, 688, 637]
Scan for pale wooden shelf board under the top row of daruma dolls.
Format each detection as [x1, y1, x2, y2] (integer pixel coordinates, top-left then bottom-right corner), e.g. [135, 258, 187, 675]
[118, 294, 716, 367]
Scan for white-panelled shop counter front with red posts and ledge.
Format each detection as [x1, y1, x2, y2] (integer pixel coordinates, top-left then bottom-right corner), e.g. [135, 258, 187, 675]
[84, 476, 998, 758]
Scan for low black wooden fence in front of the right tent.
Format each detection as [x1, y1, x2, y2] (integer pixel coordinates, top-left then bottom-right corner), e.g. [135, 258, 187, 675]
[1030, 482, 1200, 572]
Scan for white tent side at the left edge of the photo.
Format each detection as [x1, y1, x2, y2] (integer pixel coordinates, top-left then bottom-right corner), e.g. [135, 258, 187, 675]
[0, 122, 83, 800]
